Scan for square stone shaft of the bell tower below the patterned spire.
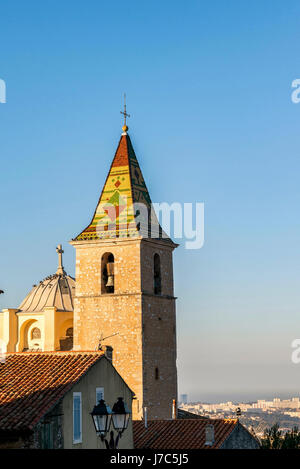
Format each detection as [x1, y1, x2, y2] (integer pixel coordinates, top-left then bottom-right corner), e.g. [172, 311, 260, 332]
[72, 239, 177, 418]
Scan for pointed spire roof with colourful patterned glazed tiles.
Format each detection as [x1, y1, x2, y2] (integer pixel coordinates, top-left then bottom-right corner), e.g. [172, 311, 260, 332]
[75, 132, 167, 241]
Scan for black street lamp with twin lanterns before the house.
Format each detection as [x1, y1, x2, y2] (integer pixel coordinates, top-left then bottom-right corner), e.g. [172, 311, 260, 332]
[91, 397, 130, 449]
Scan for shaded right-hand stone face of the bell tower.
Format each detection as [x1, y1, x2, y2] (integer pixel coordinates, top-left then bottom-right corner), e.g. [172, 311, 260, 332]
[141, 240, 177, 419]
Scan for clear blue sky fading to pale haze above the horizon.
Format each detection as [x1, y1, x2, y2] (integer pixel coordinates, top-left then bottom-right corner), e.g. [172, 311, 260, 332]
[0, 0, 300, 401]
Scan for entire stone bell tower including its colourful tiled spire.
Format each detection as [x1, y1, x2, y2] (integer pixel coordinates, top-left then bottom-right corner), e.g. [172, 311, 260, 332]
[71, 120, 177, 419]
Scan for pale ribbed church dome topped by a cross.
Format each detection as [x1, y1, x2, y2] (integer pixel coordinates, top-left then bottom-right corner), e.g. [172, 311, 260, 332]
[19, 245, 75, 312]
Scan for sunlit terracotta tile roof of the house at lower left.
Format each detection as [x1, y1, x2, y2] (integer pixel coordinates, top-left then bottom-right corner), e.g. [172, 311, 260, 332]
[0, 352, 104, 432]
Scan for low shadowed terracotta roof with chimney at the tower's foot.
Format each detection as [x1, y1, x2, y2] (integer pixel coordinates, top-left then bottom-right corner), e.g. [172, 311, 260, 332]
[133, 419, 238, 450]
